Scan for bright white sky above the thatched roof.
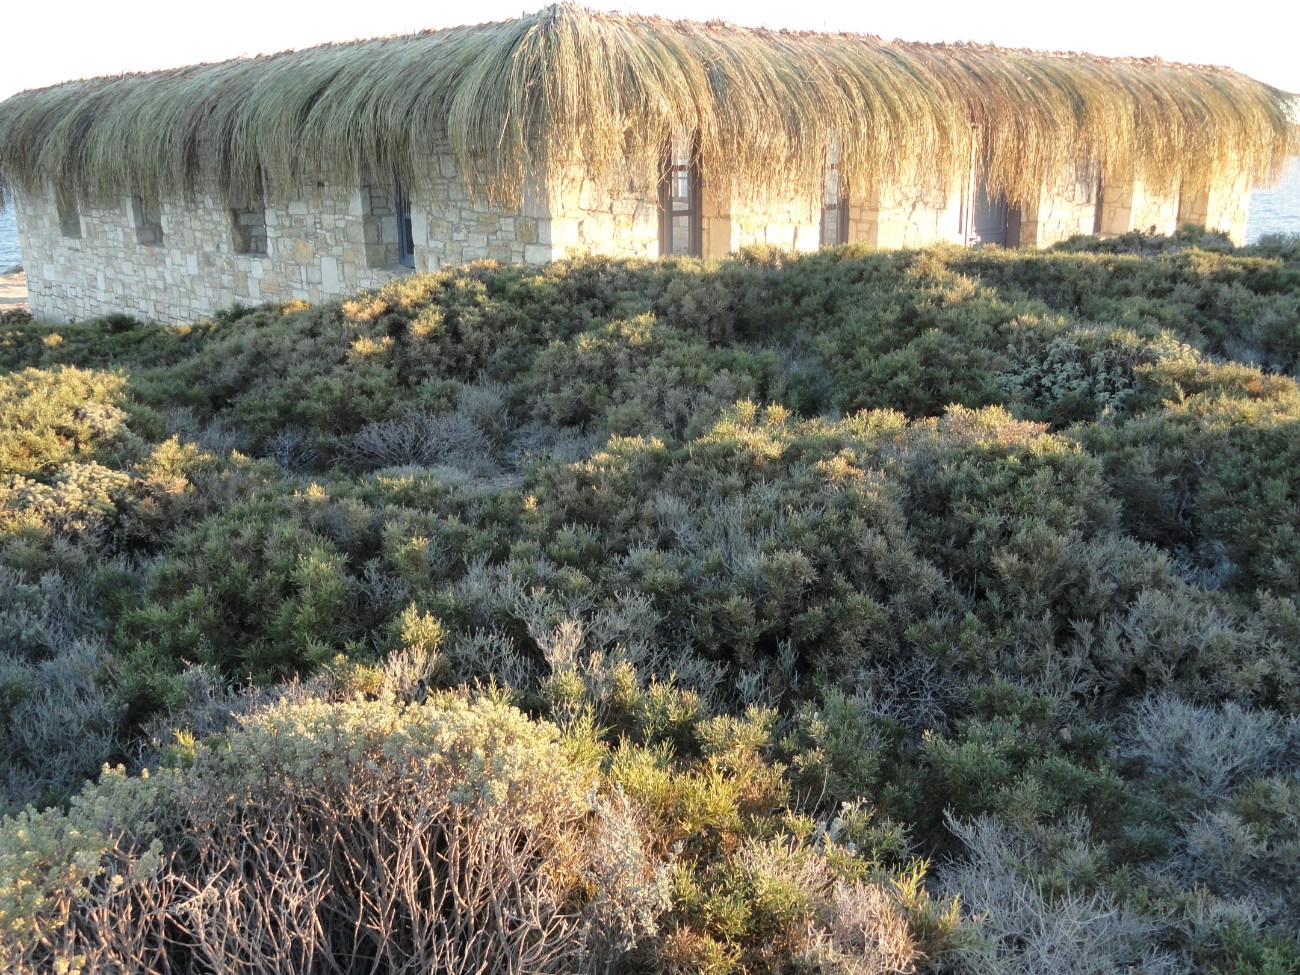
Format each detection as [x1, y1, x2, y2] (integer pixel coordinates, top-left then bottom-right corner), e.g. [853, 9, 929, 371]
[0, 0, 1300, 99]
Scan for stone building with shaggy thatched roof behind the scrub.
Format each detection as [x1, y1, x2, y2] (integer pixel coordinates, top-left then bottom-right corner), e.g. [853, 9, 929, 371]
[0, 4, 1296, 321]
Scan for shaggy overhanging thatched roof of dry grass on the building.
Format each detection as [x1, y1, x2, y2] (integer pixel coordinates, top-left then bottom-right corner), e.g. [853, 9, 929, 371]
[0, 4, 1300, 210]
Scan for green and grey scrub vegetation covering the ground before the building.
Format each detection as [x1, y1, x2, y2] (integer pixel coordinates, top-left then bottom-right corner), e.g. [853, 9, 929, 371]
[0, 230, 1300, 975]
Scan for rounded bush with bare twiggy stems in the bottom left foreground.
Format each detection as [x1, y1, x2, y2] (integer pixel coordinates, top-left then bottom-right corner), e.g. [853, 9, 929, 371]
[0, 697, 662, 974]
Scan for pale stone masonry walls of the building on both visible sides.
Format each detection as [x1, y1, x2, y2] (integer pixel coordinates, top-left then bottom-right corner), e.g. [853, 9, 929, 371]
[16, 137, 1249, 322]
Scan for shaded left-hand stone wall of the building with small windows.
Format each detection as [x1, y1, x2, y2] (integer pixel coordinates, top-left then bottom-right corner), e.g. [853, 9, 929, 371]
[16, 138, 535, 322]
